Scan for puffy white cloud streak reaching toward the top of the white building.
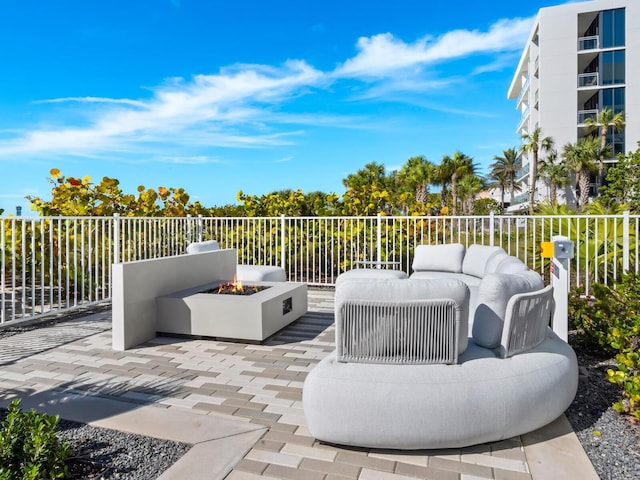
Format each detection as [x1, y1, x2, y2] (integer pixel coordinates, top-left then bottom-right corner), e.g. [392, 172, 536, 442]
[335, 18, 533, 77]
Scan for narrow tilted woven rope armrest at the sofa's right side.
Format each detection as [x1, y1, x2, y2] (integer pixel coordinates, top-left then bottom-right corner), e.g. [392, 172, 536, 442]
[500, 286, 555, 358]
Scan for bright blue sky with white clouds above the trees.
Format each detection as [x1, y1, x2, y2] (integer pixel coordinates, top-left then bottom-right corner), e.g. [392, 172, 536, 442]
[0, 0, 576, 214]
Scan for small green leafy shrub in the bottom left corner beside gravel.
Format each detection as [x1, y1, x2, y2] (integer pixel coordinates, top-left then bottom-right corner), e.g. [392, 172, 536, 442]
[0, 399, 71, 480]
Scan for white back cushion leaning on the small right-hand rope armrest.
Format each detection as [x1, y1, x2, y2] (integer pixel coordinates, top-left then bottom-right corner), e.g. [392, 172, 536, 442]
[472, 270, 544, 348]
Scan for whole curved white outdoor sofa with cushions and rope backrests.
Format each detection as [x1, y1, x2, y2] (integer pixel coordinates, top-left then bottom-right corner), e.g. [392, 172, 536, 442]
[303, 245, 578, 449]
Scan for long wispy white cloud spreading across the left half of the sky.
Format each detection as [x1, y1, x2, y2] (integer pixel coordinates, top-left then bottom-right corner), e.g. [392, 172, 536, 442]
[0, 61, 324, 157]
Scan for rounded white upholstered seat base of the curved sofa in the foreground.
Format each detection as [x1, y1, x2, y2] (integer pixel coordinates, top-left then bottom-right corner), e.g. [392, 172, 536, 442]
[303, 329, 578, 449]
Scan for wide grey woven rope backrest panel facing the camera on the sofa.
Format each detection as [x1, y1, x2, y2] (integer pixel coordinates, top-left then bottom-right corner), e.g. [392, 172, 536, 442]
[336, 299, 466, 365]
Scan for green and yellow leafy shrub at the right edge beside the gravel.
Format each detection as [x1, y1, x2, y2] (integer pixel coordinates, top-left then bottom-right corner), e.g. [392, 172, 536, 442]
[569, 275, 640, 419]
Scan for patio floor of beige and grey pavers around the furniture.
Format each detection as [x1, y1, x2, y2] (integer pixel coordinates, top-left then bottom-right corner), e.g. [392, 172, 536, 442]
[0, 288, 598, 480]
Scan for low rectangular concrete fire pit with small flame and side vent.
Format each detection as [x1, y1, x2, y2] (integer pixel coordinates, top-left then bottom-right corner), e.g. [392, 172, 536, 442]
[156, 282, 307, 342]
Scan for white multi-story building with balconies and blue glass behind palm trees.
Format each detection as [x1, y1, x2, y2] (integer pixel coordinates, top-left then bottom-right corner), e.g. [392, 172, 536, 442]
[507, 0, 640, 210]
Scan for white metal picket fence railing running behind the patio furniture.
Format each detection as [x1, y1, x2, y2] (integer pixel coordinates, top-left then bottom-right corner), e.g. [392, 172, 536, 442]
[0, 213, 640, 324]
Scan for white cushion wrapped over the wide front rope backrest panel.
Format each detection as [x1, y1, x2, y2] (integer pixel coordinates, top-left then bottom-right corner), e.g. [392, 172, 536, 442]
[335, 278, 469, 354]
